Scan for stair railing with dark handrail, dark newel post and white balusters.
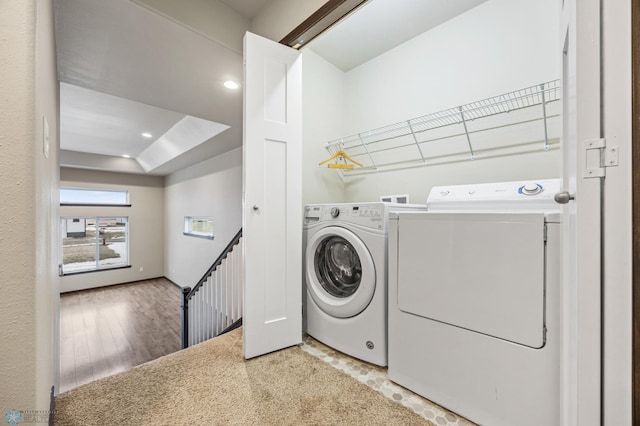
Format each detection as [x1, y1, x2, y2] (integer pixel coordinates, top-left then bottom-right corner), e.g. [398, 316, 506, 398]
[182, 229, 244, 349]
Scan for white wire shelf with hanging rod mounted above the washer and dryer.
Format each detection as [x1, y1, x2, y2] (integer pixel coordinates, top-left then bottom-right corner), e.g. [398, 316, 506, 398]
[325, 80, 561, 175]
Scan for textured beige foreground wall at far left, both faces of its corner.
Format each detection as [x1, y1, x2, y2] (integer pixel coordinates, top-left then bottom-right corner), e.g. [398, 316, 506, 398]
[0, 0, 59, 415]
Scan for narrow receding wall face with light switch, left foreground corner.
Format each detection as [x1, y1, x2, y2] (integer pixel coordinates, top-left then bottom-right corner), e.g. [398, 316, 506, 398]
[33, 0, 60, 408]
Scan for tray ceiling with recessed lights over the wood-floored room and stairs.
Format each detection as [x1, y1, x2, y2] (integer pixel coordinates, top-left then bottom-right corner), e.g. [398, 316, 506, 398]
[55, 0, 248, 175]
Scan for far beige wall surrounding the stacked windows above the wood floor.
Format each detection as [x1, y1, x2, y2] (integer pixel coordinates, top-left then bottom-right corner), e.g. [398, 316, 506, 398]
[60, 167, 164, 292]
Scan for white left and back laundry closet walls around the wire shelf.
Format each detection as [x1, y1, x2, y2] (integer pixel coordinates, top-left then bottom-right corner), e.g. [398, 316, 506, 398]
[303, 0, 561, 203]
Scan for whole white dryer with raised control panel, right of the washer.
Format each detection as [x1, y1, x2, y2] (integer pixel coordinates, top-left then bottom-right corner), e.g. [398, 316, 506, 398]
[389, 180, 562, 426]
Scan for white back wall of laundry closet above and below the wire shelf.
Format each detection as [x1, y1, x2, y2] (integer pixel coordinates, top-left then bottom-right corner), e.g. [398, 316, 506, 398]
[320, 0, 560, 202]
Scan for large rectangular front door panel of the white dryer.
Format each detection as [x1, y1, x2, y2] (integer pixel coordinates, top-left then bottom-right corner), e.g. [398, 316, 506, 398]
[397, 212, 545, 348]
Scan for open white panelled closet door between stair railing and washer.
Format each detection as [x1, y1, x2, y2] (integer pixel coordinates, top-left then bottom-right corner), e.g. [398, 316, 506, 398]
[243, 33, 302, 358]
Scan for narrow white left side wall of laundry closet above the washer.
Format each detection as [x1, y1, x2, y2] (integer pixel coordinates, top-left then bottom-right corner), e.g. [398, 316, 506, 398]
[302, 49, 345, 205]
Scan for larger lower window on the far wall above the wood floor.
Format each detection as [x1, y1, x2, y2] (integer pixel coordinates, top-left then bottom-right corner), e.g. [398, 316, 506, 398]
[60, 217, 129, 275]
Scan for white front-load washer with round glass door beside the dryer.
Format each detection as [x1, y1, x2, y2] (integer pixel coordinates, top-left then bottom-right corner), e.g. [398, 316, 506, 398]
[303, 202, 426, 366]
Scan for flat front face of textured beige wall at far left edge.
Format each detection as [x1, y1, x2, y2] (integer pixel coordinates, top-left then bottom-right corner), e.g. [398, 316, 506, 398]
[0, 0, 36, 415]
